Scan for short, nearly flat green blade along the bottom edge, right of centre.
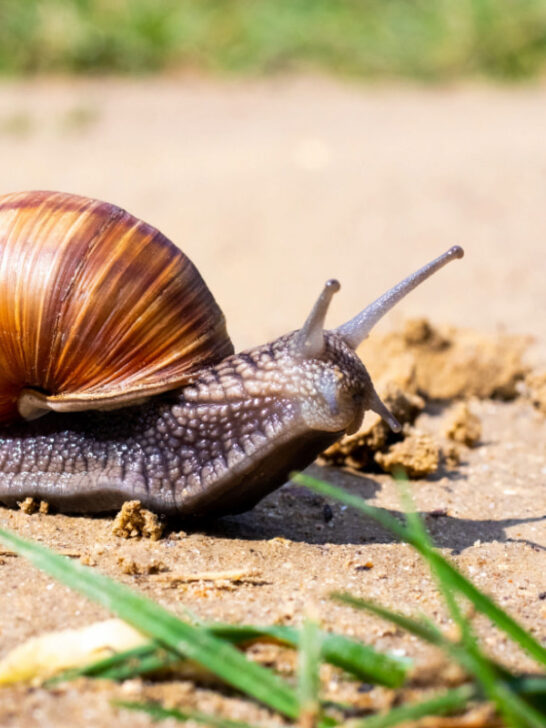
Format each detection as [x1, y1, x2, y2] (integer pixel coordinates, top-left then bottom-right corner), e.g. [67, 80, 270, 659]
[350, 685, 475, 728]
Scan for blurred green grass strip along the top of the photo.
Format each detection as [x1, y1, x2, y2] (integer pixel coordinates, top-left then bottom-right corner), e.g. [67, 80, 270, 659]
[0, 0, 546, 80]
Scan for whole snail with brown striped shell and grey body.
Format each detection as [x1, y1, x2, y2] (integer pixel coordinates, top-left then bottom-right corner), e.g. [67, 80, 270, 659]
[0, 192, 463, 517]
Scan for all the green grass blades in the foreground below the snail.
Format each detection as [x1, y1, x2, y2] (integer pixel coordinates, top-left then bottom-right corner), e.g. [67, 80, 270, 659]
[0, 475, 546, 728]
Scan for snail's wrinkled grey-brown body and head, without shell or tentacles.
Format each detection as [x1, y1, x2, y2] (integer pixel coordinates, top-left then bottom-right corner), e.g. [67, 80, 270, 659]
[0, 332, 373, 517]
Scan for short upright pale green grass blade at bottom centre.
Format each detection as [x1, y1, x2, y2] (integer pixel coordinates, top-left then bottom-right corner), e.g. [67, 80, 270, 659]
[298, 619, 321, 726]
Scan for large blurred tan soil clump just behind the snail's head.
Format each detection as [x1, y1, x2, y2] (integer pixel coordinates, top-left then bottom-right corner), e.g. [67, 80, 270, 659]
[358, 319, 529, 400]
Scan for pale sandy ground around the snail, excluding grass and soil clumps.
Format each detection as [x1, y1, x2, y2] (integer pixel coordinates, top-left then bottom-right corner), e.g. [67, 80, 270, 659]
[0, 79, 546, 728]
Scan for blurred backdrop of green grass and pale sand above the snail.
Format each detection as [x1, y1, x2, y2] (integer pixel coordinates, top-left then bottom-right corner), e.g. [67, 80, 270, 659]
[0, 0, 546, 351]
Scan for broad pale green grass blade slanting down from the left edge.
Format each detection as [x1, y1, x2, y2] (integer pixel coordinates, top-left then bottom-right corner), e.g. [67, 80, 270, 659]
[0, 529, 299, 718]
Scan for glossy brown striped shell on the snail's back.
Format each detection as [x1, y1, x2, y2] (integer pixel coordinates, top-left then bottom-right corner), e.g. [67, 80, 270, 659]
[0, 192, 233, 423]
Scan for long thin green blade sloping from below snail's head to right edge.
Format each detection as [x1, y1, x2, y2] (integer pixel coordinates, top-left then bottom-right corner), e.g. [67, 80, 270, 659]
[292, 473, 546, 667]
